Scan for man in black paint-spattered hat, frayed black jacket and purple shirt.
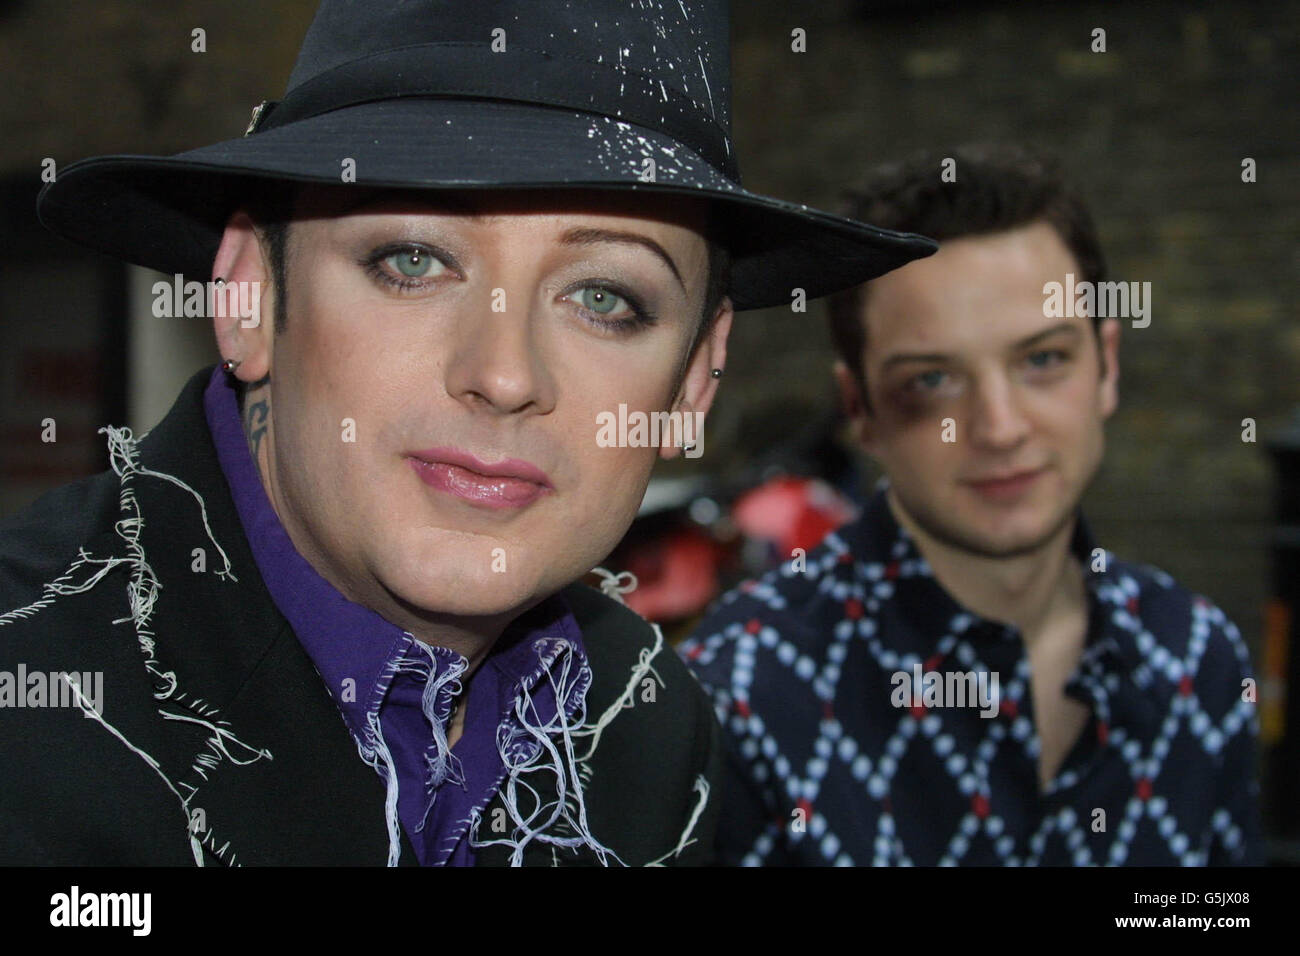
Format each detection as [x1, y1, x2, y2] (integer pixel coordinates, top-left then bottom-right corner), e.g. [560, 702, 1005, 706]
[0, 0, 933, 865]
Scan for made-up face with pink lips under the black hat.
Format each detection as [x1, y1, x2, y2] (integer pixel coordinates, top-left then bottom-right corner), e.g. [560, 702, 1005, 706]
[227, 189, 729, 627]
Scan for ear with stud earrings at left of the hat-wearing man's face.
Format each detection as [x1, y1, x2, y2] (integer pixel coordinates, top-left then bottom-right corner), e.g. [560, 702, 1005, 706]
[212, 209, 276, 382]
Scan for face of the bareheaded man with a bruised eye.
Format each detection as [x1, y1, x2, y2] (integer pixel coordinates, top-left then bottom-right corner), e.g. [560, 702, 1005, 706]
[839, 222, 1119, 557]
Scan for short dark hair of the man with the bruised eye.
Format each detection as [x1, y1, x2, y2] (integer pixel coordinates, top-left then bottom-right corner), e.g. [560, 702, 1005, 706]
[827, 143, 1106, 408]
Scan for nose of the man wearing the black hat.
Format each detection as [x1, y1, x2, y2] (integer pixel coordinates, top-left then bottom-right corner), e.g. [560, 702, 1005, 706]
[446, 287, 555, 415]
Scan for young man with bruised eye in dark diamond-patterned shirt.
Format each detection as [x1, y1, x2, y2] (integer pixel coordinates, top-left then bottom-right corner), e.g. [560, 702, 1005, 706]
[683, 141, 1262, 865]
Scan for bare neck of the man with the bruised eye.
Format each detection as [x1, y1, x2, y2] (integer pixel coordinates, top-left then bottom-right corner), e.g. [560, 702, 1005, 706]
[887, 489, 1087, 644]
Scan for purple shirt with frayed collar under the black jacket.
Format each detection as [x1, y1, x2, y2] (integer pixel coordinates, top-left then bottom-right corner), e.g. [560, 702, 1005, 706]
[204, 365, 590, 866]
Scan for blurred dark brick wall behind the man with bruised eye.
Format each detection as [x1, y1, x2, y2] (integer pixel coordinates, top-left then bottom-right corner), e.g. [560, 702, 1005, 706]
[710, 0, 1300, 644]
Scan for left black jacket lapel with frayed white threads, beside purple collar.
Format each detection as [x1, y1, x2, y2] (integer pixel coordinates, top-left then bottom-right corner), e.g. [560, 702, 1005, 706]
[130, 371, 416, 865]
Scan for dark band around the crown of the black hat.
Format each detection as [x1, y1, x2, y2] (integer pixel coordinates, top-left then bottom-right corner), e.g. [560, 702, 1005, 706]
[255, 43, 740, 183]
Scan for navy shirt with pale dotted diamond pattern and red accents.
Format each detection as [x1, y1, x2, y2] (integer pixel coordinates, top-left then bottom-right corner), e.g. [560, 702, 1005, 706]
[681, 489, 1262, 866]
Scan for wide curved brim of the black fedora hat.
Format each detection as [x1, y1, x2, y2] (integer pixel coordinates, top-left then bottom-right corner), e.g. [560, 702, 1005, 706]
[38, 98, 936, 310]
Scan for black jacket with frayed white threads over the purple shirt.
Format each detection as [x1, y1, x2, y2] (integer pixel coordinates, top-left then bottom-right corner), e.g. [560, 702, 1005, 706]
[0, 371, 720, 865]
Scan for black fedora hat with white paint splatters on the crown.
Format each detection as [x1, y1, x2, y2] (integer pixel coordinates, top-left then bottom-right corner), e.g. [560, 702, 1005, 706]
[38, 0, 936, 310]
